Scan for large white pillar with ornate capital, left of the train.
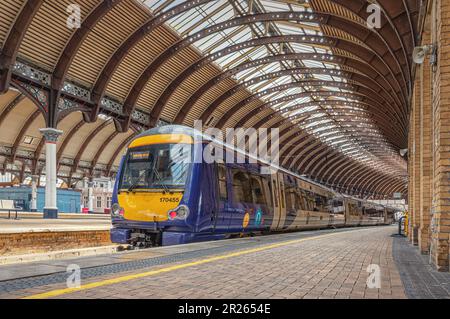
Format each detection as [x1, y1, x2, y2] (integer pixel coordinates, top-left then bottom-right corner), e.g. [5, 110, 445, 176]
[39, 128, 63, 218]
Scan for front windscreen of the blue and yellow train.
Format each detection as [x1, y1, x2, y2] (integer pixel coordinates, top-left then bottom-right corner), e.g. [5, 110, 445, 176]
[119, 144, 192, 191]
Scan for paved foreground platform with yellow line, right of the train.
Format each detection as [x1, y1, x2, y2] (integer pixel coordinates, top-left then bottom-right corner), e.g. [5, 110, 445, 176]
[0, 226, 450, 299]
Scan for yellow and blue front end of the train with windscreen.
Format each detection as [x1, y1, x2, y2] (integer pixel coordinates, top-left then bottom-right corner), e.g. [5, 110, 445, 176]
[111, 128, 196, 247]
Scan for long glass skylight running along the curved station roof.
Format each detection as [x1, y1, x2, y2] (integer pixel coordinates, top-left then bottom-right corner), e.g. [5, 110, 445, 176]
[141, 0, 406, 180]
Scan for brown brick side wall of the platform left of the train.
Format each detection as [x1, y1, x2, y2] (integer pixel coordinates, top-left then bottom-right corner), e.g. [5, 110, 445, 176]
[0, 230, 111, 256]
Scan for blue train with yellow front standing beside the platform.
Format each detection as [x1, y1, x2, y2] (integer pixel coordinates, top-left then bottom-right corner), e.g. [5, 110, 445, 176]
[110, 125, 395, 247]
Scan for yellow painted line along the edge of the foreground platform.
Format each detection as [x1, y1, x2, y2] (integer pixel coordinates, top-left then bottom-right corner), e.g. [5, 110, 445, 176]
[23, 230, 361, 299]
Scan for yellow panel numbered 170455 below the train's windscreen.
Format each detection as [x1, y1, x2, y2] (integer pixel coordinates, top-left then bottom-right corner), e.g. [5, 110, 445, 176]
[118, 192, 183, 222]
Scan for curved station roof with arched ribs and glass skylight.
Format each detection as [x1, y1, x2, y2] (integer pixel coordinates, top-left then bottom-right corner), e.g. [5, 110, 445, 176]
[0, 0, 422, 198]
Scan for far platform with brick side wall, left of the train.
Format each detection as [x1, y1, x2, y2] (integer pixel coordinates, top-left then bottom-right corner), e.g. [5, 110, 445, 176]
[0, 212, 112, 265]
